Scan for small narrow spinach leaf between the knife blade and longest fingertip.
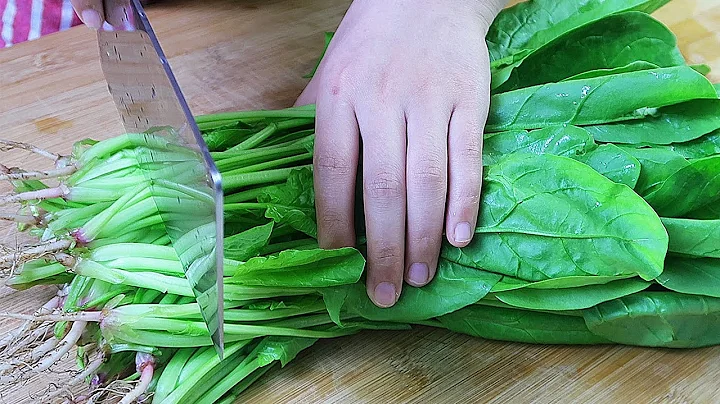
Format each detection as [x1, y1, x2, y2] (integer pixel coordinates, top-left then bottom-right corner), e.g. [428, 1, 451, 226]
[225, 248, 365, 288]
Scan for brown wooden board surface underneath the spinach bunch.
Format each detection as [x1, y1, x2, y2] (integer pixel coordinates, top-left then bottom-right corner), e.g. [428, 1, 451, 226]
[0, 0, 720, 403]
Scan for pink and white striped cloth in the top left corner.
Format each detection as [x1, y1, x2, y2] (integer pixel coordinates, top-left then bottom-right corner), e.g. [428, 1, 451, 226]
[0, 0, 81, 48]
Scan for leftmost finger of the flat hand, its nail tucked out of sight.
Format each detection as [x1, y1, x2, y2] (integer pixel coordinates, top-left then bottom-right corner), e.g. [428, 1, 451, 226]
[313, 92, 360, 248]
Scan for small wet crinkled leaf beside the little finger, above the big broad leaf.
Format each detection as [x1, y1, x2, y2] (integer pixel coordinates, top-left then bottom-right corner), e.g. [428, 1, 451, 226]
[483, 125, 595, 165]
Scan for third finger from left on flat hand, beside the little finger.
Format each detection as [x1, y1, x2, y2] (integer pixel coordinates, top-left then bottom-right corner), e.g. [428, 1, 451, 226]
[405, 107, 450, 287]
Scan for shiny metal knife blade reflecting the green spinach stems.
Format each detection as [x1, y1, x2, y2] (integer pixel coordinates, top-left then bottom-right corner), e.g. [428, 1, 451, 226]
[98, 0, 224, 358]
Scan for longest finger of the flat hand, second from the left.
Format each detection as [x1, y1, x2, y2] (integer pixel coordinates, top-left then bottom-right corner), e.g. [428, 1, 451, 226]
[357, 108, 406, 307]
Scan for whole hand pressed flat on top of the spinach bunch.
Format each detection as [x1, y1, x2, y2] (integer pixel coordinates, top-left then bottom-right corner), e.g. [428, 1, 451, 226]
[296, 0, 506, 307]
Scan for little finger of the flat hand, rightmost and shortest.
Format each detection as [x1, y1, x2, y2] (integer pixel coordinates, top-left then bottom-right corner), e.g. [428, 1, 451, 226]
[445, 105, 487, 247]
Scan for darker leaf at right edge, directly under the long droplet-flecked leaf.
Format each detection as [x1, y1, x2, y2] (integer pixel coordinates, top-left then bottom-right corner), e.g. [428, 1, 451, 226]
[585, 99, 720, 145]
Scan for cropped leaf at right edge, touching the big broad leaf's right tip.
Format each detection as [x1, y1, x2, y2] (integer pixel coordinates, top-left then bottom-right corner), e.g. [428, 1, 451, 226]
[661, 217, 720, 258]
